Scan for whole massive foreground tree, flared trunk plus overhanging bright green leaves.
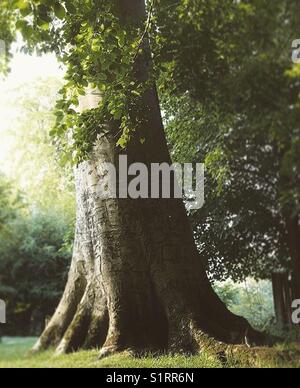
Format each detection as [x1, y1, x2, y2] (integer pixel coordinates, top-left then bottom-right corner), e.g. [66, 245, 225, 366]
[2, 0, 272, 356]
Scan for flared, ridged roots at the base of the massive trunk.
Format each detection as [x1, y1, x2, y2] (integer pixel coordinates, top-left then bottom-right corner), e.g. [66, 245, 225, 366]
[34, 274, 277, 364]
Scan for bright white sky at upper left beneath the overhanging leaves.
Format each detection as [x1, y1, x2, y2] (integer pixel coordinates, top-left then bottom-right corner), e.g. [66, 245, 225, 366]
[0, 42, 63, 172]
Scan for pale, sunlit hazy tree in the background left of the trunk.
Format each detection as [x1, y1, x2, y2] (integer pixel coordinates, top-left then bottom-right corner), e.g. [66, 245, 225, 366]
[4, 75, 75, 214]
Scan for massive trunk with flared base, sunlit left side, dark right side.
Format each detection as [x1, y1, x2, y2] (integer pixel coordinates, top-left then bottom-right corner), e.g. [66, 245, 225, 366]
[35, 0, 264, 356]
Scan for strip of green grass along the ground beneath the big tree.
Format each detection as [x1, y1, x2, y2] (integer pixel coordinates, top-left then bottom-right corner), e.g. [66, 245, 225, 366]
[0, 338, 300, 368]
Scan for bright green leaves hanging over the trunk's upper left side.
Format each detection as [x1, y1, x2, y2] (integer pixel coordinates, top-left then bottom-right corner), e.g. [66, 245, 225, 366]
[1, 0, 157, 163]
